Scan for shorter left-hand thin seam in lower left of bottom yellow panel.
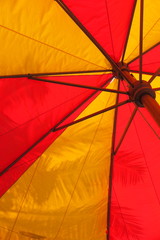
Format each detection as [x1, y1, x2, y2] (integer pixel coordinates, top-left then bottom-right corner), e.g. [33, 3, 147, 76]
[7, 159, 39, 240]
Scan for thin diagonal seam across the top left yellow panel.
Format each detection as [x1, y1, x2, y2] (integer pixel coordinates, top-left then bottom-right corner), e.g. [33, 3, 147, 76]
[0, 25, 105, 69]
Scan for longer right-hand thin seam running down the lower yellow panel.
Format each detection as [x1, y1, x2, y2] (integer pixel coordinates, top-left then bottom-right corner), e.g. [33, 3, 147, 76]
[54, 81, 117, 240]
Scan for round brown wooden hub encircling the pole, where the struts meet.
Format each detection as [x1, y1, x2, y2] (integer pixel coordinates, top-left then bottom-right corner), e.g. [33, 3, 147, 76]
[129, 81, 156, 107]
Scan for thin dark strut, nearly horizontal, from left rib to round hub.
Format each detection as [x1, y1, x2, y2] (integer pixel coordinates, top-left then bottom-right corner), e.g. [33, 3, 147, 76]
[28, 76, 128, 95]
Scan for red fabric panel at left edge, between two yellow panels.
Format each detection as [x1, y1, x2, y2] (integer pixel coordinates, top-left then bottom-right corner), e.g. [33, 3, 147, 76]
[0, 75, 111, 194]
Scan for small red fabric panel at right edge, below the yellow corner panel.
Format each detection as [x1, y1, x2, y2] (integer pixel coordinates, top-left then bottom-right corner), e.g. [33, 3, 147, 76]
[129, 44, 160, 73]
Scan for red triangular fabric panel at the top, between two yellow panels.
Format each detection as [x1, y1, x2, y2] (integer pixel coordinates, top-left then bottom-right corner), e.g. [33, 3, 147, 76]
[63, 0, 135, 62]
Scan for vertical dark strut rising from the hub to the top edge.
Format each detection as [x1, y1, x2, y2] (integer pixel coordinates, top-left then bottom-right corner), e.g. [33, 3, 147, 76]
[139, 0, 144, 82]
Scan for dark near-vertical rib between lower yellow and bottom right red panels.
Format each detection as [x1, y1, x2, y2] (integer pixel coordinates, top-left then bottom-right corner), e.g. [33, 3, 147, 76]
[106, 79, 120, 240]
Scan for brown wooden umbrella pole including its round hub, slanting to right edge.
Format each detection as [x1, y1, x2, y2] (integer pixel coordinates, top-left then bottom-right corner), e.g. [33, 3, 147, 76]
[122, 67, 160, 127]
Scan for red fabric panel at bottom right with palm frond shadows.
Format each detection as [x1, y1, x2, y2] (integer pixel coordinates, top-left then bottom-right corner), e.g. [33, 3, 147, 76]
[110, 82, 160, 240]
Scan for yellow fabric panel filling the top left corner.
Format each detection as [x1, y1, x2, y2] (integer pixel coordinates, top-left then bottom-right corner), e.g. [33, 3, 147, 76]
[0, 0, 110, 75]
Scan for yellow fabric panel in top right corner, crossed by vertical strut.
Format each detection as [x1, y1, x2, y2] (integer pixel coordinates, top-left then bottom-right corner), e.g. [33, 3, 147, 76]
[125, 0, 160, 63]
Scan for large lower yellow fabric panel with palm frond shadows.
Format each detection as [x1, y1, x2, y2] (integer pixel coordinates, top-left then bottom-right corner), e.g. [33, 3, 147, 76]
[0, 80, 117, 240]
